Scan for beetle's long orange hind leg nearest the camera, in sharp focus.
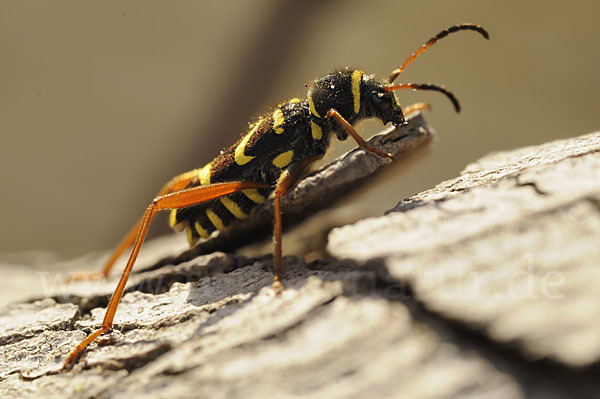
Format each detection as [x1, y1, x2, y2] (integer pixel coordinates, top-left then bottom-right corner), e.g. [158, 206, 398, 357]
[63, 182, 271, 369]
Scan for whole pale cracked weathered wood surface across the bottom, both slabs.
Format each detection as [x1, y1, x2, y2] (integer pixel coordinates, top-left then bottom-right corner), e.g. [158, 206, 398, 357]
[0, 122, 600, 399]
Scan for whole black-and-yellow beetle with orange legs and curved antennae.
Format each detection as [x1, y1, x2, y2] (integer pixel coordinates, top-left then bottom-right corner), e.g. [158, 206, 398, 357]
[63, 24, 489, 368]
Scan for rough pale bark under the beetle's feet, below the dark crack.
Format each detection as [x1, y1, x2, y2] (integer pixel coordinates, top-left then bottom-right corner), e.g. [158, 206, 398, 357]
[0, 258, 519, 398]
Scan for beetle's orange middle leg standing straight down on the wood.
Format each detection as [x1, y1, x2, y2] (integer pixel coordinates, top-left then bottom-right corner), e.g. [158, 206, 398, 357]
[273, 155, 322, 294]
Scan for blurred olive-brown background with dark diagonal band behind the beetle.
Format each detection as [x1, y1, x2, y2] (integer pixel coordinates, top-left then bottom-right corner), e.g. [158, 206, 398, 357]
[0, 0, 600, 257]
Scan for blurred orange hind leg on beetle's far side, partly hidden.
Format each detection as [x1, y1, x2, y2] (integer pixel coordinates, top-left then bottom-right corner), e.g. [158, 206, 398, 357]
[70, 170, 203, 281]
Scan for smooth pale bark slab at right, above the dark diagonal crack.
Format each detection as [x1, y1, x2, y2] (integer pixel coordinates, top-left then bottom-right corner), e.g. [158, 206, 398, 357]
[328, 133, 600, 367]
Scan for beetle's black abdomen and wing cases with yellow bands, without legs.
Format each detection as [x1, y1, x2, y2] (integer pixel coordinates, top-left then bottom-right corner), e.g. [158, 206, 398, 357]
[170, 99, 327, 245]
